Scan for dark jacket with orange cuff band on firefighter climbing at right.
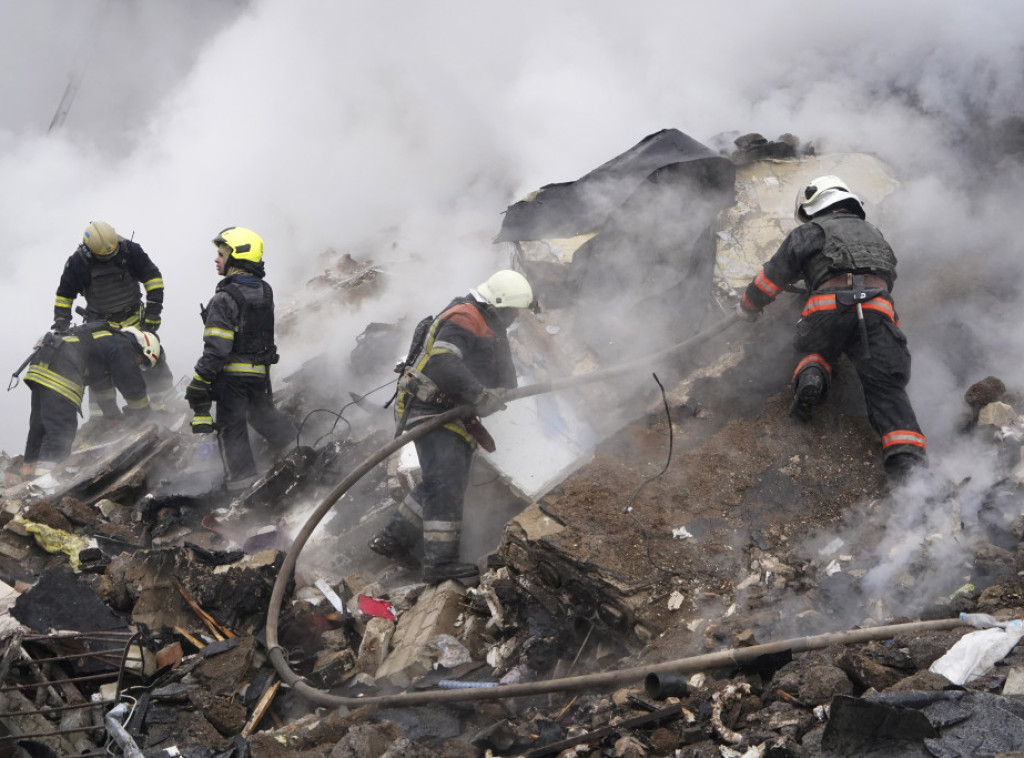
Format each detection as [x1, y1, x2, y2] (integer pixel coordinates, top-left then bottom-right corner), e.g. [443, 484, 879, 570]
[743, 211, 896, 310]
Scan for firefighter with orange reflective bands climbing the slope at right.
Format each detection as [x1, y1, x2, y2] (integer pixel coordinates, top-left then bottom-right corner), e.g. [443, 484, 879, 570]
[736, 175, 927, 479]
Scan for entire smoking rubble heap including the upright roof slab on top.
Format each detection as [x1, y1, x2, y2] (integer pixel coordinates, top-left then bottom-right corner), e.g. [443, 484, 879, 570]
[0, 130, 1024, 758]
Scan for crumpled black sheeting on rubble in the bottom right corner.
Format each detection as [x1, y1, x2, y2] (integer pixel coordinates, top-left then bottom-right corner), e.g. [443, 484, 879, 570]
[821, 689, 1024, 758]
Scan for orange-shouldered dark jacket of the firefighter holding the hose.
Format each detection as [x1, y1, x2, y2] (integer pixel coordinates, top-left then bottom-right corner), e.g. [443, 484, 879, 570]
[395, 296, 516, 444]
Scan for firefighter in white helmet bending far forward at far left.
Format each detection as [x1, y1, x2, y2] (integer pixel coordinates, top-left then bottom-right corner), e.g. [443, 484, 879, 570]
[20, 322, 161, 477]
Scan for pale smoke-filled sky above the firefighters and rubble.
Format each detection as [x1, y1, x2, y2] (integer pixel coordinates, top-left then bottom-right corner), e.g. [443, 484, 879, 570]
[0, 0, 1024, 473]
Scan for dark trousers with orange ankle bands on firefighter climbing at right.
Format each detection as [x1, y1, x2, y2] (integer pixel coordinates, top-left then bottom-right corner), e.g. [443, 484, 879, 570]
[794, 307, 927, 461]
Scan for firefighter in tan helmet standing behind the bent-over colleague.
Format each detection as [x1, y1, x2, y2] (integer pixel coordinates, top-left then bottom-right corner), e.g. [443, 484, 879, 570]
[50, 221, 174, 405]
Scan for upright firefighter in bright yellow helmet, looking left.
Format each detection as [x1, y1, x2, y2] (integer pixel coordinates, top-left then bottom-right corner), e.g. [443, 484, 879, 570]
[185, 226, 297, 491]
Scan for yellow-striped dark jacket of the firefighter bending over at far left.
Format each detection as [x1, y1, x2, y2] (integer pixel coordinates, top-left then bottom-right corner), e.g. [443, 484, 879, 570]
[25, 322, 150, 418]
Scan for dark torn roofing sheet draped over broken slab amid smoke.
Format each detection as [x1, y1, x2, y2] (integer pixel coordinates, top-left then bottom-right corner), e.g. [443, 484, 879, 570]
[495, 129, 735, 364]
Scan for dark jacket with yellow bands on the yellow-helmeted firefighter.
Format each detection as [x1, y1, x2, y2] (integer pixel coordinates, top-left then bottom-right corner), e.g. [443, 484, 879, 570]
[196, 273, 278, 383]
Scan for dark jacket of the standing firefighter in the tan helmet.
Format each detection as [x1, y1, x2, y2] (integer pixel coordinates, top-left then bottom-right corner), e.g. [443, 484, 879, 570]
[53, 237, 164, 332]
